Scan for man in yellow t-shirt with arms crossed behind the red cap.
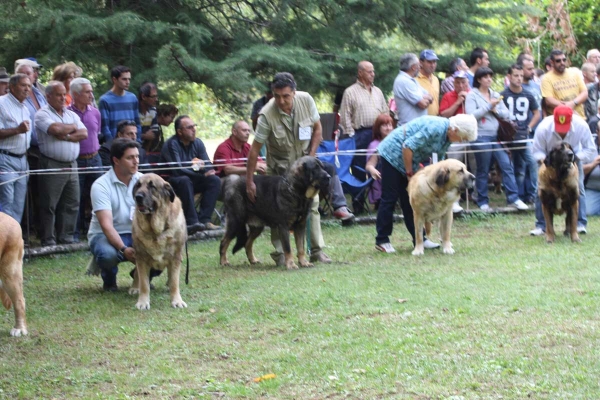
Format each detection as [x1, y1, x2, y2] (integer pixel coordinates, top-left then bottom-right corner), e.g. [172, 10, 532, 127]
[542, 50, 588, 118]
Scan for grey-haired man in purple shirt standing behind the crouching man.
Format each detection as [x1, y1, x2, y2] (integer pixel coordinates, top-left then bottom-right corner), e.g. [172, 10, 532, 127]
[67, 78, 102, 239]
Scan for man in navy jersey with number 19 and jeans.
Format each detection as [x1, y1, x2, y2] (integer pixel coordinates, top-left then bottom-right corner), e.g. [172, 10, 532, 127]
[500, 64, 540, 203]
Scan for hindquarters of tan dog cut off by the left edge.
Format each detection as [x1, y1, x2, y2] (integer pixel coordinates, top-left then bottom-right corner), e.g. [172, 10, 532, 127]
[0, 212, 27, 336]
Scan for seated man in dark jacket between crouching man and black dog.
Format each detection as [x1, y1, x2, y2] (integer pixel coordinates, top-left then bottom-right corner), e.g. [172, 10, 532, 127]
[161, 115, 221, 235]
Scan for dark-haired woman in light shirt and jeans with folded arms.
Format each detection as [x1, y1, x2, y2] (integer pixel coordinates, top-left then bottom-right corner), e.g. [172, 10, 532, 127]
[465, 67, 529, 211]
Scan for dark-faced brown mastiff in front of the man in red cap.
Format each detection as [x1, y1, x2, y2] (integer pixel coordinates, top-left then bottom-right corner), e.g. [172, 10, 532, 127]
[538, 142, 581, 243]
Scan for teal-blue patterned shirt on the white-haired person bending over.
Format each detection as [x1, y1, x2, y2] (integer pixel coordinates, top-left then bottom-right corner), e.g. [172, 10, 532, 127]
[377, 115, 451, 174]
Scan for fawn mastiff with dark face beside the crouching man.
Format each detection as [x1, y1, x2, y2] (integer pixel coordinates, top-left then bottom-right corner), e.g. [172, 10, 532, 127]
[129, 174, 187, 310]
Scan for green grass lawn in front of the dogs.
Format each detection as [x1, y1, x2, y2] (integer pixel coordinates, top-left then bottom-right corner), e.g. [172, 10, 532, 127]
[0, 213, 600, 399]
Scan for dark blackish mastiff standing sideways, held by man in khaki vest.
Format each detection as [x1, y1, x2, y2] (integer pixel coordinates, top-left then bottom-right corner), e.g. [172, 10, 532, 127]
[219, 156, 331, 269]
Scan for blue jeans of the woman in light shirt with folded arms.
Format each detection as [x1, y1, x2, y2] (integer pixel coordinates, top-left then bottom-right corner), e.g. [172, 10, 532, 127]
[474, 136, 519, 207]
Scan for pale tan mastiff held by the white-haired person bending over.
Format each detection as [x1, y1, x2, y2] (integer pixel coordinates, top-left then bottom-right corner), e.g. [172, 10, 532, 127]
[408, 159, 475, 256]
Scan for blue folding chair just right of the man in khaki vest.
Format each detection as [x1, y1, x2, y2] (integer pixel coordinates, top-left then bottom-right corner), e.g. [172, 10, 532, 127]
[317, 137, 373, 215]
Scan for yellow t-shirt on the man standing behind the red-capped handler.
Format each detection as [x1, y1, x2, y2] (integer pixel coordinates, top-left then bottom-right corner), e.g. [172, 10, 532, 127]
[542, 68, 585, 118]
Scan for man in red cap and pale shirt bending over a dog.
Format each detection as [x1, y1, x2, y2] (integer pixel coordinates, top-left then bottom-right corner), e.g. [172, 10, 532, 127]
[529, 105, 598, 236]
